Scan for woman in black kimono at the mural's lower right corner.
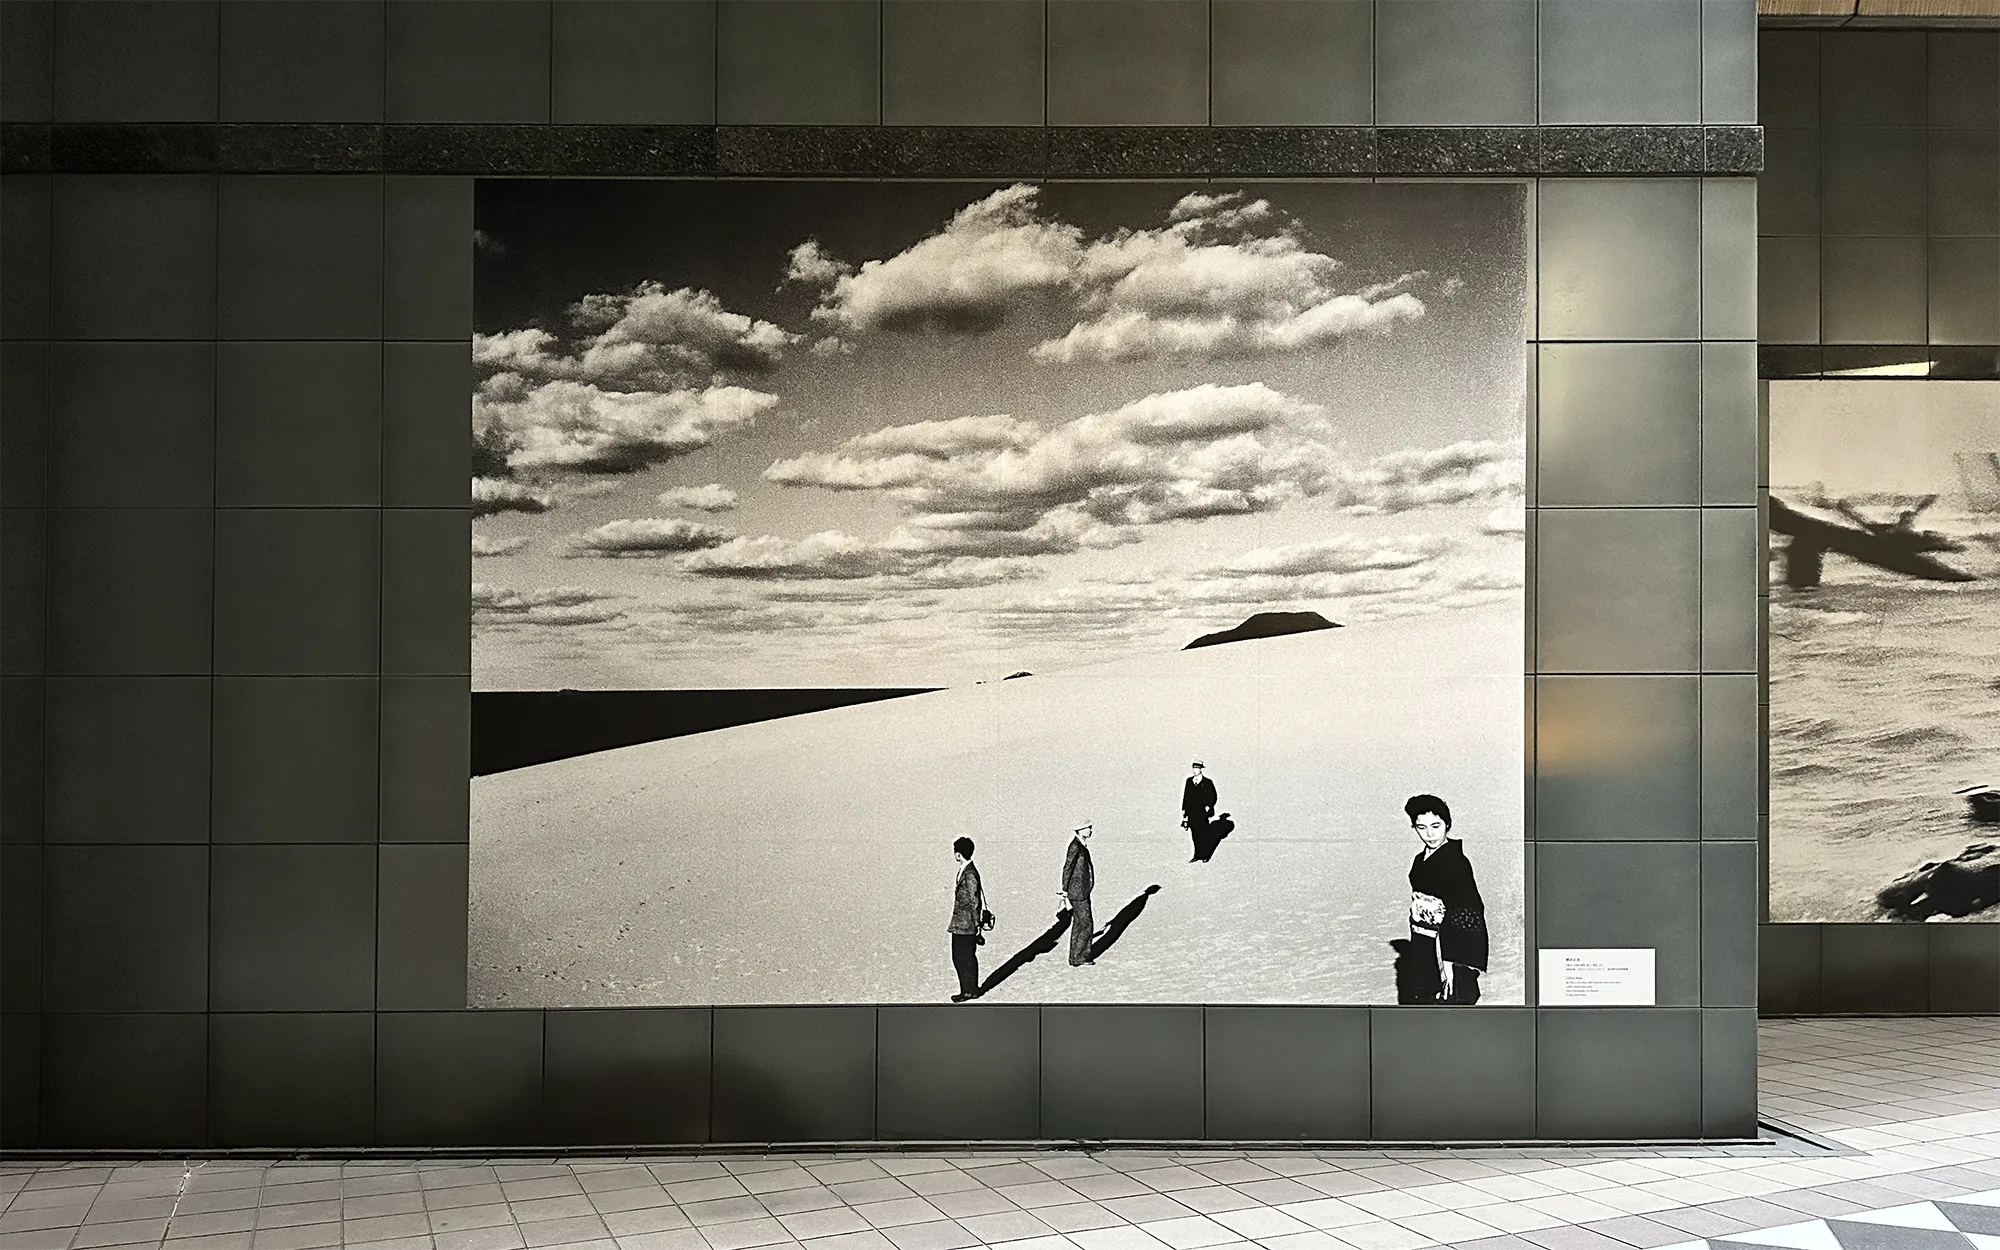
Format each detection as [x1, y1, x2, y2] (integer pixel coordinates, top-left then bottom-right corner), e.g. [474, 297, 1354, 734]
[1398, 794, 1486, 1004]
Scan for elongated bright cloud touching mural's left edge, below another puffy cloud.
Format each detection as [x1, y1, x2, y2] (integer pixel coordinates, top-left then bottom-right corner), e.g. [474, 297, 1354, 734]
[472, 372, 778, 474]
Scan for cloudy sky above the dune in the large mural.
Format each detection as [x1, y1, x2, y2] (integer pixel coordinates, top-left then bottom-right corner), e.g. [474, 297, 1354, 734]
[472, 180, 1526, 690]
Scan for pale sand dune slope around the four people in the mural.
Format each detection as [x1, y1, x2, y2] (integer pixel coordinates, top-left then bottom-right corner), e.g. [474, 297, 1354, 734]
[468, 606, 1522, 1006]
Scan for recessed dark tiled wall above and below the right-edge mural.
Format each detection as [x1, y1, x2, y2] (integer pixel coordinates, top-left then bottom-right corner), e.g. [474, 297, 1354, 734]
[1758, 30, 2000, 1014]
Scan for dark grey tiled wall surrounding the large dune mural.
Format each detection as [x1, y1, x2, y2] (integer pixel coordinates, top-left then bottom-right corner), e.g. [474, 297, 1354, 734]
[0, 0, 1758, 1148]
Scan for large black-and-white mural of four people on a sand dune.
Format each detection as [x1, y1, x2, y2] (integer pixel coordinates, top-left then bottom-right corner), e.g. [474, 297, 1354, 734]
[468, 180, 1526, 1006]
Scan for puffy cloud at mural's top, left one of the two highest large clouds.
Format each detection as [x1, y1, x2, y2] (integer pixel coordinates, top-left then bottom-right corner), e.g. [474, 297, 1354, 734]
[790, 184, 1082, 334]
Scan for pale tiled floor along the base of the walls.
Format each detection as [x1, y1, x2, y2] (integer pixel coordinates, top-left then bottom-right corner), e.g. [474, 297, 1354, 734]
[0, 1020, 2000, 1250]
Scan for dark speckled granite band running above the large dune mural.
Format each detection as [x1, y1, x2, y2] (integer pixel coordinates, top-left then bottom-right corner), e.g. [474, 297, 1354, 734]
[0, 122, 1764, 178]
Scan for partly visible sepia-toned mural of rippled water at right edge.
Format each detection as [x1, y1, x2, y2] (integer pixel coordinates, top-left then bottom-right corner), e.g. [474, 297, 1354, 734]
[1770, 378, 2000, 922]
